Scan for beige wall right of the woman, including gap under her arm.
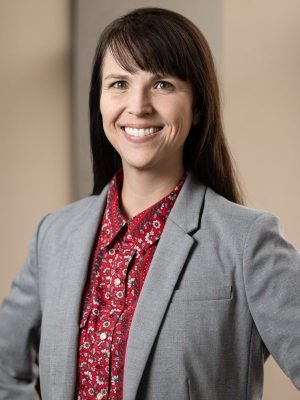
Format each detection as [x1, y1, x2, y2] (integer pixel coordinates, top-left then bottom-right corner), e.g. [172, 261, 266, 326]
[223, 0, 300, 400]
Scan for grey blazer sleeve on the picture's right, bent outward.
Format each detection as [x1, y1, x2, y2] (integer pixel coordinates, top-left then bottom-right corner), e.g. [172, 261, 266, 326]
[243, 213, 300, 390]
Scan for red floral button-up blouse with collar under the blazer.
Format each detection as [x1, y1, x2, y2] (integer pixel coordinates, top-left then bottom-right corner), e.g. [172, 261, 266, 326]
[75, 174, 185, 400]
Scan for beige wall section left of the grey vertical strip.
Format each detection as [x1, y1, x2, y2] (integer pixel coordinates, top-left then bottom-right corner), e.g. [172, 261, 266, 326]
[0, 0, 71, 299]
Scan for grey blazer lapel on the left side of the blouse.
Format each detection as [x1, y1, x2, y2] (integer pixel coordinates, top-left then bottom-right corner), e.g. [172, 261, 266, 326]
[49, 190, 106, 400]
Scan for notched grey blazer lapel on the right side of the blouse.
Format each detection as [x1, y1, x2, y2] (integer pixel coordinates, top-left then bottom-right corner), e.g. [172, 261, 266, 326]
[123, 174, 206, 400]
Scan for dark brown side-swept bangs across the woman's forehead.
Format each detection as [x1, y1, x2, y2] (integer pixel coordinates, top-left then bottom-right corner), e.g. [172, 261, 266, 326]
[107, 20, 190, 81]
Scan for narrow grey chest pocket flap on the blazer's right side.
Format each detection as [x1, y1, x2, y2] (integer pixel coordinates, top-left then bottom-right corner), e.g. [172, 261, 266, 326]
[172, 286, 232, 302]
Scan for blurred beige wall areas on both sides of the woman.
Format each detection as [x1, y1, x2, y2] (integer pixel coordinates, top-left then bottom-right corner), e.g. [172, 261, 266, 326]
[0, 0, 300, 400]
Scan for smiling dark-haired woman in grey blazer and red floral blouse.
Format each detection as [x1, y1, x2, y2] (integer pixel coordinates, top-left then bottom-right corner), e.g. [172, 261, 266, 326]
[0, 8, 300, 400]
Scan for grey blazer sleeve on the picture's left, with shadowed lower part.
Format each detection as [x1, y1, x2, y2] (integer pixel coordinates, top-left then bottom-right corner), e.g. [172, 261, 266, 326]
[0, 219, 48, 400]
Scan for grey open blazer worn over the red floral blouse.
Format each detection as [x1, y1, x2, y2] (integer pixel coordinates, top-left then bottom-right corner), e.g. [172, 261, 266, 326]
[0, 175, 300, 400]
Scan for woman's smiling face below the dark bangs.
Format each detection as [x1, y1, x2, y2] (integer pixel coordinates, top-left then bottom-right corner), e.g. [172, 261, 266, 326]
[100, 51, 197, 172]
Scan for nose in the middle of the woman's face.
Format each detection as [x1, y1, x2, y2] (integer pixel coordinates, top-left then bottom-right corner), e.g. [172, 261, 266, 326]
[127, 88, 153, 117]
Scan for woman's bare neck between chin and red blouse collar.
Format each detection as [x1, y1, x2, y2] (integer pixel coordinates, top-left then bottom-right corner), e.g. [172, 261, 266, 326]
[121, 162, 184, 218]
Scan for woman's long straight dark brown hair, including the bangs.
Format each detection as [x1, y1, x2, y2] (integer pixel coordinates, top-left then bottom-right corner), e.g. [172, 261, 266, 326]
[89, 8, 243, 204]
